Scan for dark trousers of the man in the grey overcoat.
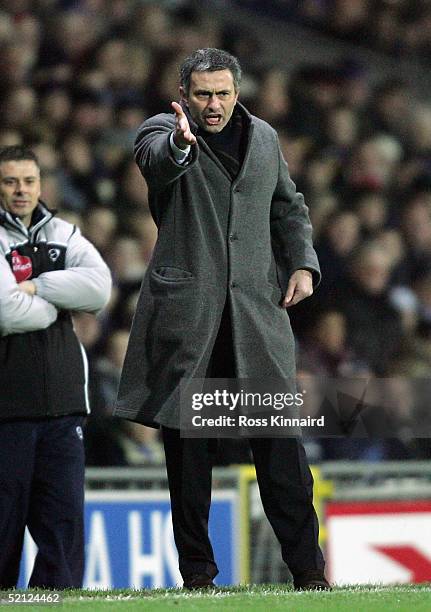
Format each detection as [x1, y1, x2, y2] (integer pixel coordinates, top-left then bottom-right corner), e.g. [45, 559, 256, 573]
[162, 307, 325, 579]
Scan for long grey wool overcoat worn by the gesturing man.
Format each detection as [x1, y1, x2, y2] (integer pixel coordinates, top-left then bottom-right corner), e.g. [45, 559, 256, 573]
[115, 103, 320, 428]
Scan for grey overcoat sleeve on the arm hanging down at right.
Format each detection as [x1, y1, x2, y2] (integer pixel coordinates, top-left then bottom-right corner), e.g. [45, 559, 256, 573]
[270, 138, 321, 287]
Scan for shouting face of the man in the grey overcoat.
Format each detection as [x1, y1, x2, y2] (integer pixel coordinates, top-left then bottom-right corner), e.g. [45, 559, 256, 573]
[180, 70, 238, 134]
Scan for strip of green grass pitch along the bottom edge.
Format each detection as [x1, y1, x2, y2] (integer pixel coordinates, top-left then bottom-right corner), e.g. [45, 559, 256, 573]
[5, 584, 431, 612]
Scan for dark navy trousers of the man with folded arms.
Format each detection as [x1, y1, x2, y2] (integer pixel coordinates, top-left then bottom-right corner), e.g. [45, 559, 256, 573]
[0, 416, 85, 589]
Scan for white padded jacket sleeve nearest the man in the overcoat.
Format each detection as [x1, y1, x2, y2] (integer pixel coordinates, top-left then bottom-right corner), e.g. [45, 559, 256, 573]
[33, 227, 111, 312]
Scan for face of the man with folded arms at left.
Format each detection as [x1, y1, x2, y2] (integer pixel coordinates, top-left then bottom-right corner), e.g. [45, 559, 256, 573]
[0, 159, 40, 227]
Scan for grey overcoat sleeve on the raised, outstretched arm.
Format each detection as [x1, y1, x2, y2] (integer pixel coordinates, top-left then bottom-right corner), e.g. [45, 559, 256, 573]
[135, 115, 199, 190]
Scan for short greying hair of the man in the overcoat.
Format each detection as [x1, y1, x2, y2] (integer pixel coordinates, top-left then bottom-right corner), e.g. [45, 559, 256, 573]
[180, 48, 242, 94]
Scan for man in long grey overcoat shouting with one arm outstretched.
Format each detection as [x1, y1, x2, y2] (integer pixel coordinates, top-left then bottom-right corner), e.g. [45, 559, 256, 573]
[116, 49, 329, 589]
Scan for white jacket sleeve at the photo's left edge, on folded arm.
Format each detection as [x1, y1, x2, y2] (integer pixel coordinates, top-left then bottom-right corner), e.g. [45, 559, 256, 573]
[0, 253, 57, 336]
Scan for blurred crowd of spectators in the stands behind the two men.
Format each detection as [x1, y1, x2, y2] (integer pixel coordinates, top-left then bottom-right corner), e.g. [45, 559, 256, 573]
[0, 0, 431, 465]
